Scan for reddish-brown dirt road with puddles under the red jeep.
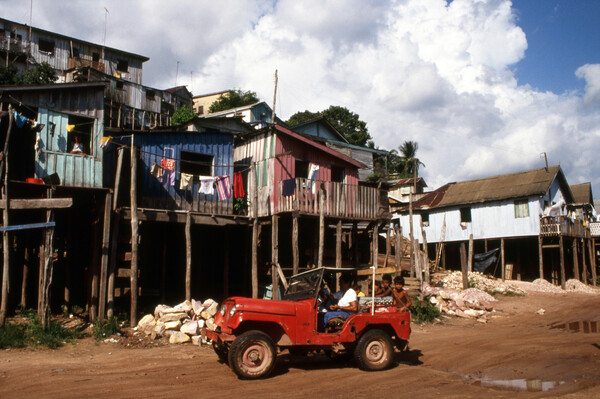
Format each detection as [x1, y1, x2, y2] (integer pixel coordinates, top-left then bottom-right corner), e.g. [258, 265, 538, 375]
[0, 293, 600, 399]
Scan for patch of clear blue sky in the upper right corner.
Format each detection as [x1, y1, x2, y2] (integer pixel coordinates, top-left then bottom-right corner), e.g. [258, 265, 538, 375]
[513, 0, 600, 94]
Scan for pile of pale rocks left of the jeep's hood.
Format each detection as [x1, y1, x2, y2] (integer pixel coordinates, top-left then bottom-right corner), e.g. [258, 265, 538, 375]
[137, 299, 219, 345]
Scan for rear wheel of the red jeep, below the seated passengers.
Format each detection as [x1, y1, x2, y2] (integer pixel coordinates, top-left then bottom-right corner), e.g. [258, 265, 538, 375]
[354, 330, 394, 371]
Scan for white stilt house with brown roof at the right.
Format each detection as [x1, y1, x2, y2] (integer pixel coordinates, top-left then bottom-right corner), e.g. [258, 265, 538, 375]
[393, 166, 600, 286]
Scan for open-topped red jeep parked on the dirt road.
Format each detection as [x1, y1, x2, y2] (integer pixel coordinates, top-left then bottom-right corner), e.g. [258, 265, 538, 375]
[202, 268, 410, 379]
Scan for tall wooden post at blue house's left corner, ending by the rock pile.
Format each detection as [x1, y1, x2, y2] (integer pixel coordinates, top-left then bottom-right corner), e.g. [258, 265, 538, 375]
[129, 144, 139, 327]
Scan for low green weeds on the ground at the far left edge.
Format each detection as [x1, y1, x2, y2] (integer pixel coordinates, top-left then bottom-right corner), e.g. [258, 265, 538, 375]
[0, 309, 81, 349]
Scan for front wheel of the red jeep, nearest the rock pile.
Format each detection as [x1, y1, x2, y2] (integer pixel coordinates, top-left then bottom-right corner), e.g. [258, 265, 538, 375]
[228, 331, 277, 379]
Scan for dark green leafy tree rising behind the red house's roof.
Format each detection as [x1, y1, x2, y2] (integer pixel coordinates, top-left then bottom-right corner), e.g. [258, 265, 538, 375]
[286, 105, 371, 146]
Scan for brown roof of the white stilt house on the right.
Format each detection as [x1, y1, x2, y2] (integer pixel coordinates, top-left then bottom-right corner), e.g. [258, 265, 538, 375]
[400, 165, 573, 211]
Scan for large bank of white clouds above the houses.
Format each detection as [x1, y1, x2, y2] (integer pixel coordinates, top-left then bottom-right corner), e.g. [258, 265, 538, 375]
[0, 0, 600, 192]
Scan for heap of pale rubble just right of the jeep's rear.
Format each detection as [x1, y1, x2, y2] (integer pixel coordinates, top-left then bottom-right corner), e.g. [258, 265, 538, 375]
[421, 283, 496, 323]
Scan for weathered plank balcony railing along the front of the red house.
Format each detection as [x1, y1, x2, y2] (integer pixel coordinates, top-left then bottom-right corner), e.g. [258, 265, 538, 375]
[275, 178, 388, 219]
